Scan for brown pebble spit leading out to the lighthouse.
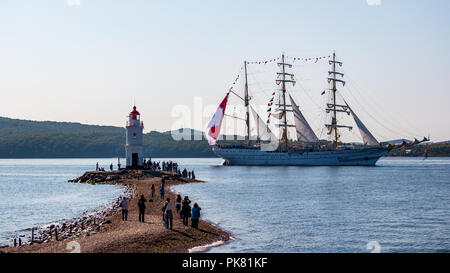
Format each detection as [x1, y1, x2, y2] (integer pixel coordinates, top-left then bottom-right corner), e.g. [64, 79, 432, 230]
[0, 170, 232, 253]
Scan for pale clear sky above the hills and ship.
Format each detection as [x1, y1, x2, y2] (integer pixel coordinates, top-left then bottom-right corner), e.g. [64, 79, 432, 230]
[0, 0, 450, 141]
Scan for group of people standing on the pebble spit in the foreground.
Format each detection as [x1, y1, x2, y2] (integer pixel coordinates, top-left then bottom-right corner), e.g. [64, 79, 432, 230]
[120, 177, 201, 229]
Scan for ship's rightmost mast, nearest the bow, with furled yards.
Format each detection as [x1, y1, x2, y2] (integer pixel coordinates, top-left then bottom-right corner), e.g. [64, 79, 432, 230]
[325, 52, 352, 149]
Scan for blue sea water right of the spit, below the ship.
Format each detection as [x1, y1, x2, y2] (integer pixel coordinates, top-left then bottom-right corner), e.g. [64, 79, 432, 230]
[171, 158, 450, 253]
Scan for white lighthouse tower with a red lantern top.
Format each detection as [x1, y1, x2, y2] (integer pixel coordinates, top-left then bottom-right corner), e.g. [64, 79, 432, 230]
[125, 106, 144, 169]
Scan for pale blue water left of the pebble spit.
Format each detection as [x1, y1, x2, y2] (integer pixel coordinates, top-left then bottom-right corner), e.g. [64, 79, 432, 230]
[0, 159, 123, 245]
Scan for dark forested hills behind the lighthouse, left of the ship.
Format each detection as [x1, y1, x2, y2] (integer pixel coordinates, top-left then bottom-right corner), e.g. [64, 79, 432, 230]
[0, 117, 214, 158]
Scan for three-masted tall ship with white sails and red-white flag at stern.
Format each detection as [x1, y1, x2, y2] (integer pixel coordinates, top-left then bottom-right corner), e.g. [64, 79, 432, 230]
[206, 53, 429, 166]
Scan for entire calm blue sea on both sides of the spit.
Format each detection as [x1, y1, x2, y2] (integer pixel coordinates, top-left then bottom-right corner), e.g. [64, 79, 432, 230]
[0, 158, 450, 252]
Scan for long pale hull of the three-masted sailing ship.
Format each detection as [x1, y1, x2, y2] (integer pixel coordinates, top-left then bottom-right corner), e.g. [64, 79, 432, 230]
[213, 147, 389, 166]
